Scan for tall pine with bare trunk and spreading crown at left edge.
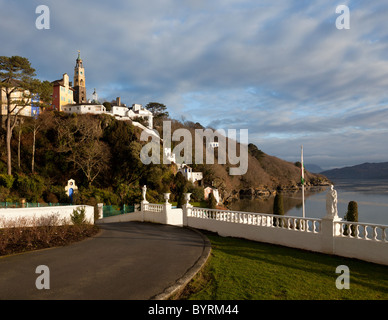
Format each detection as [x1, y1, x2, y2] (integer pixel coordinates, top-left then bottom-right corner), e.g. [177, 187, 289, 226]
[0, 56, 47, 175]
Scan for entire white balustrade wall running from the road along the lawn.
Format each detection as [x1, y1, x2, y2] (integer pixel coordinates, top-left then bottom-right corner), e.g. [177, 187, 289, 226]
[104, 201, 388, 265]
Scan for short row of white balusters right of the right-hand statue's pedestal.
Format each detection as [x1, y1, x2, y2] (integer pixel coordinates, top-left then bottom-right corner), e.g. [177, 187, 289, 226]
[335, 221, 388, 243]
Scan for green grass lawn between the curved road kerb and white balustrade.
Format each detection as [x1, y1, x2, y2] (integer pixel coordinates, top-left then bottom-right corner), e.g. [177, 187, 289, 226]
[179, 232, 388, 300]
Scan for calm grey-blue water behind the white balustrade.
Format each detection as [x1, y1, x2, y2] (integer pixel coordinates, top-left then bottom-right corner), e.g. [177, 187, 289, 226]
[230, 180, 388, 225]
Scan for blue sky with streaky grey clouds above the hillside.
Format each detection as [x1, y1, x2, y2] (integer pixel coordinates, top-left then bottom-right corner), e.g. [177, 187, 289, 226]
[0, 0, 388, 169]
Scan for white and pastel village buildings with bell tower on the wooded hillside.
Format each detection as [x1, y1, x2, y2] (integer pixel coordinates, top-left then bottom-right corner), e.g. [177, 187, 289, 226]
[0, 51, 221, 203]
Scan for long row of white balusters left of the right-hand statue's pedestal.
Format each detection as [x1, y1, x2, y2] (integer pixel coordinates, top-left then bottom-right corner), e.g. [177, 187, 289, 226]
[188, 207, 321, 233]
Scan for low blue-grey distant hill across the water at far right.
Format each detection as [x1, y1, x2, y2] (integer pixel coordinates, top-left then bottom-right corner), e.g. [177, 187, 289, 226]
[321, 162, 388, 179]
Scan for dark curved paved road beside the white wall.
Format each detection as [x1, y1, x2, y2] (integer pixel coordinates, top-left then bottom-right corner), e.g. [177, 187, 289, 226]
[0, 222, 209, 300]
